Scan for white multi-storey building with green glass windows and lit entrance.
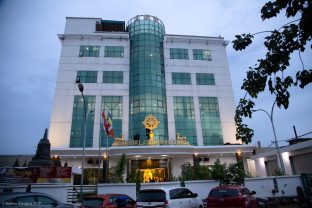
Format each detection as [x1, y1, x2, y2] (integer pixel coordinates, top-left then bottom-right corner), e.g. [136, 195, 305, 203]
[49, 15, 255, 184]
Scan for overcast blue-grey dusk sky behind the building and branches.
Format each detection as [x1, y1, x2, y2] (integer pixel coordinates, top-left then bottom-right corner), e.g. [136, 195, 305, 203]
[0, 0, 312, 154]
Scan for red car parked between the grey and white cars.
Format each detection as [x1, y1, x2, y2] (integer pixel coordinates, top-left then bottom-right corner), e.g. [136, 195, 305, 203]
[81, 194, 135, 208]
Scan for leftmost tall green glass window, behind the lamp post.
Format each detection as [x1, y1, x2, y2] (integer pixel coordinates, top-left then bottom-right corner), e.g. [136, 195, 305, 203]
[69, 96, 95, 147]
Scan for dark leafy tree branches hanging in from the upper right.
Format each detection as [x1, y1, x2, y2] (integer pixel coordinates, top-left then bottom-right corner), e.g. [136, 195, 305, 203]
[233, 0, 312, 144]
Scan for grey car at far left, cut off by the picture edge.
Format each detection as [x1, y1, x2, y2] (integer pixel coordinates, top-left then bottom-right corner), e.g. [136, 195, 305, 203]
[0, 192, 75, 208]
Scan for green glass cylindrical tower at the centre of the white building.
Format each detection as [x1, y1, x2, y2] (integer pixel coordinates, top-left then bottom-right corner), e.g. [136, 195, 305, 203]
[127, 15, 168, 141]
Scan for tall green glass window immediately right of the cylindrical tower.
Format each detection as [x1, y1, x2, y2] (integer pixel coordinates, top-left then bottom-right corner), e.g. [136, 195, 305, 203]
[173, 97, 197, 145]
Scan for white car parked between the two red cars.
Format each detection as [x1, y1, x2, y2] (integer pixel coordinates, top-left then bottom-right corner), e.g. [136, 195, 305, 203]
[136, 187, 203, 208]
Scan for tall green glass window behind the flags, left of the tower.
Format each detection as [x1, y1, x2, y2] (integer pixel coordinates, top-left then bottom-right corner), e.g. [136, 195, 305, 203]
[100, 96, 123, 147]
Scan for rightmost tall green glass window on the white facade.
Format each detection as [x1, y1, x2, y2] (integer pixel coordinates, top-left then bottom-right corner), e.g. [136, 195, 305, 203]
[198, 97, 223, 145]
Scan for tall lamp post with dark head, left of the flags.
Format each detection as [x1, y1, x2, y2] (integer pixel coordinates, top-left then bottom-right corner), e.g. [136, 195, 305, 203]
[78, 83, 87, 199]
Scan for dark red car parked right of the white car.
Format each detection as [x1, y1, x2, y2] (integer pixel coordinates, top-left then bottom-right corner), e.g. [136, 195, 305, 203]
[206, 185, 257, 208]
